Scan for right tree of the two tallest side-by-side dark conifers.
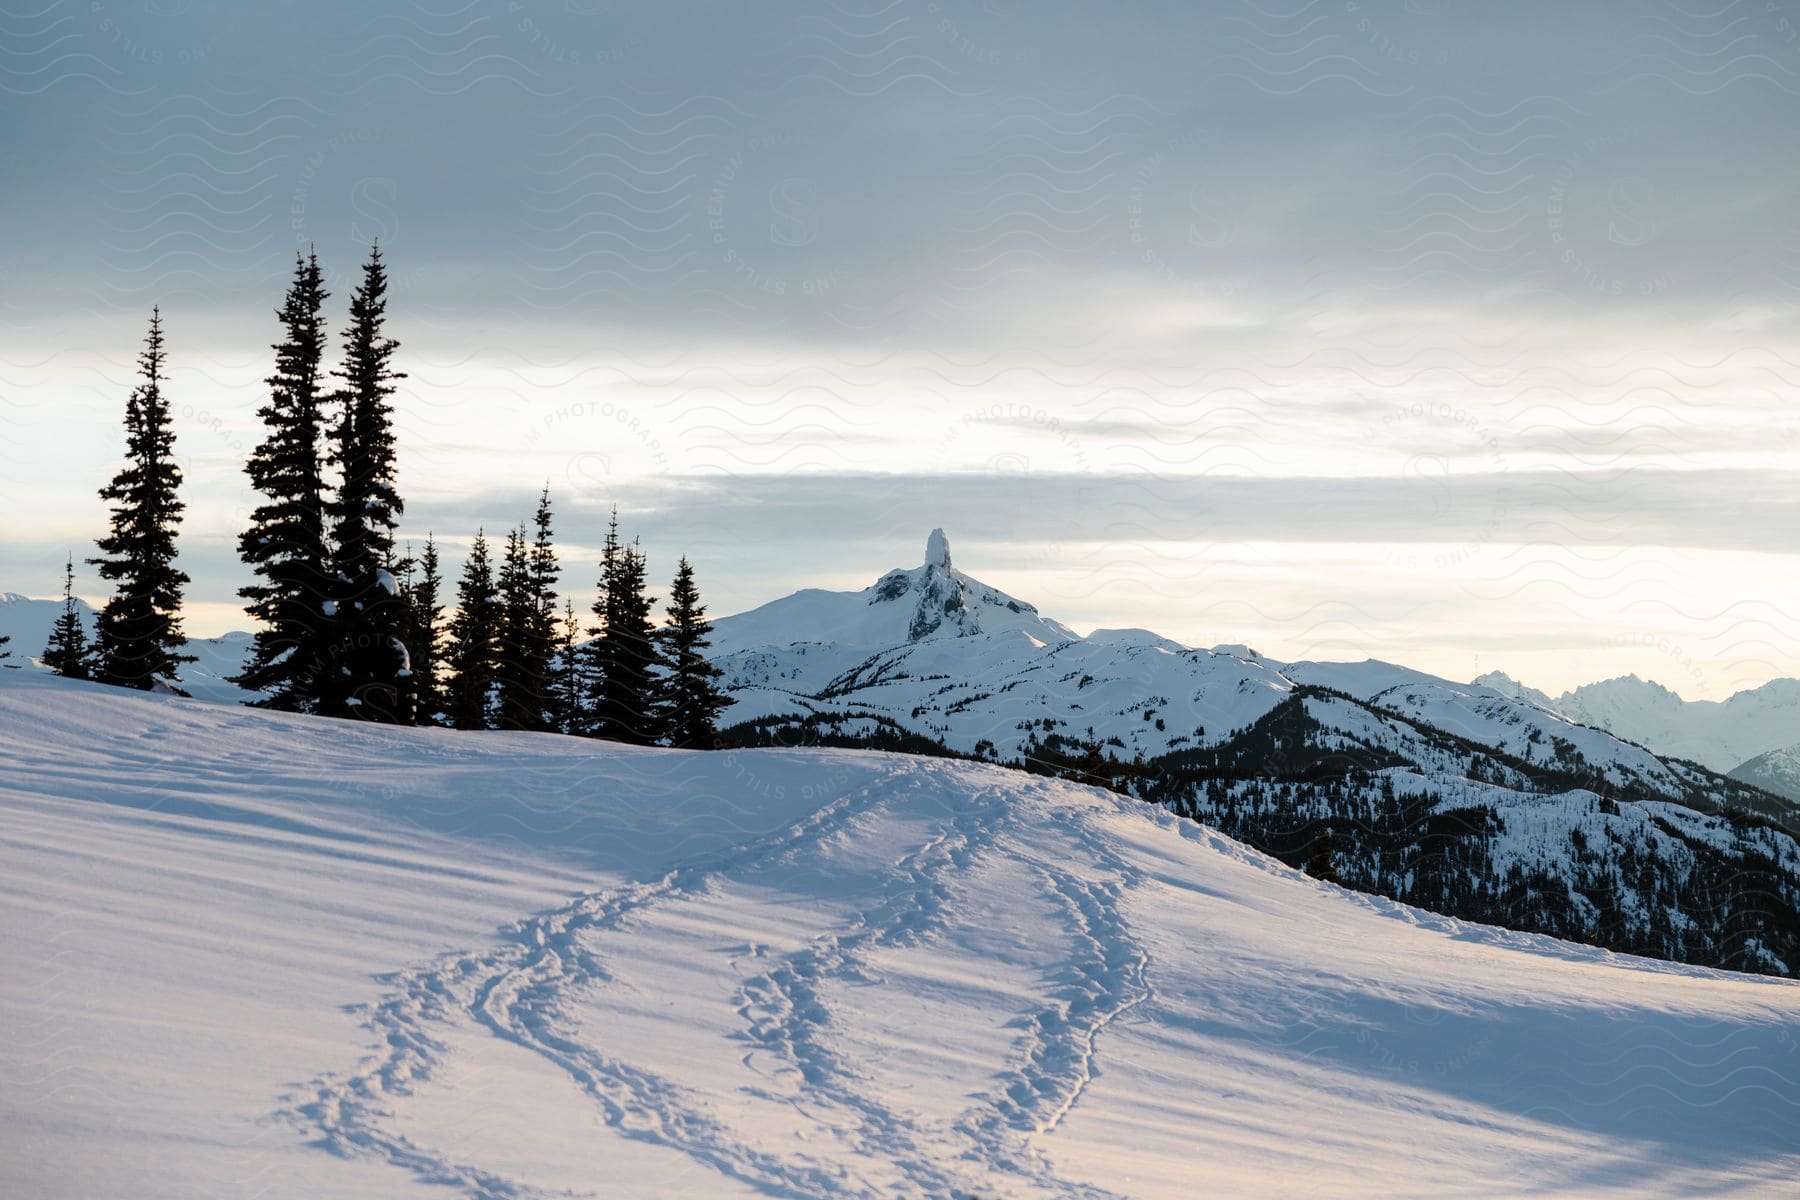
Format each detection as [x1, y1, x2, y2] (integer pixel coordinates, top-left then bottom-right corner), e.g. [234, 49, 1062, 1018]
[322, 246, 412, 723]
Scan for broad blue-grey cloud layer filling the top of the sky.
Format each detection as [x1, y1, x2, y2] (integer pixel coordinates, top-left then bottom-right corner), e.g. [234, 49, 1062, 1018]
[0, 0, 1800, 344]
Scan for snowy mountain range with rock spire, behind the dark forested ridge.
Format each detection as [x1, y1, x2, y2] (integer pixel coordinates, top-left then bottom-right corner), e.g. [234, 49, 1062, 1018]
[713, 529, 1800, 799]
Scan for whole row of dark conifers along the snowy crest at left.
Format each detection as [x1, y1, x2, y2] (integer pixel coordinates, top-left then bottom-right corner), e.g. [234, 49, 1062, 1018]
[33, 248, 727, 747]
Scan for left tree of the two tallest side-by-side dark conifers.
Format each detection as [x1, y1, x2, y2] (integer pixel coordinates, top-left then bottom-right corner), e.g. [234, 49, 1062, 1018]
[232, 254, 338, 712]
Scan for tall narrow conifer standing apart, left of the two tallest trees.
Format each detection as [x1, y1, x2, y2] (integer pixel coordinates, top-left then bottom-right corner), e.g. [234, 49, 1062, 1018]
[88, 309, 194, 689]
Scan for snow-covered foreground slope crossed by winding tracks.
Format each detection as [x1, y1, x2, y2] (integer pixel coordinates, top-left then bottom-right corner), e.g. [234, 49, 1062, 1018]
[0, 671, 1800, 1200]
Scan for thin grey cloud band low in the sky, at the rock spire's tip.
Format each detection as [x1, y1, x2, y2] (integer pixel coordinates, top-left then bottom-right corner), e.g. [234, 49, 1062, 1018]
[316, 470, 1800, 612]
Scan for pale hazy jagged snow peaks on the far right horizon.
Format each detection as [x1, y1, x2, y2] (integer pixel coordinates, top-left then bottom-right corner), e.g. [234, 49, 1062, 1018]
[1476, 673, 1800, 772]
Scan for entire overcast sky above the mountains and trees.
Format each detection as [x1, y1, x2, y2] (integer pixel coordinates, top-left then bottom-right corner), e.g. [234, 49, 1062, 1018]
[0, 0, 1800, 698]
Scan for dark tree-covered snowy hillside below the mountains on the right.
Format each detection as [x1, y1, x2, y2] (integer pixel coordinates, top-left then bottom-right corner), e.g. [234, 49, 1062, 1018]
[1137, 693, 1800, 975]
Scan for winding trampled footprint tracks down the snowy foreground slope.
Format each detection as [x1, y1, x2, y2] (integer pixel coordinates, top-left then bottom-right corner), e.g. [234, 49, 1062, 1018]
[286, 766, 1150, 1200]
